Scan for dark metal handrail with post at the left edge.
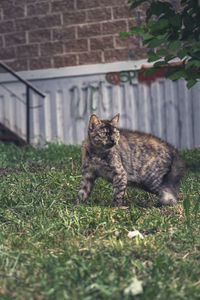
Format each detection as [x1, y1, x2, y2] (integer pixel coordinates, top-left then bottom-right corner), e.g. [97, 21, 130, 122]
[0, 62, 45, 144]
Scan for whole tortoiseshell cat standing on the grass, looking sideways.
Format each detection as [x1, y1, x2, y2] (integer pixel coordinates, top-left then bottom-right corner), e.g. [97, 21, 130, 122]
[75, 114, 184, 206]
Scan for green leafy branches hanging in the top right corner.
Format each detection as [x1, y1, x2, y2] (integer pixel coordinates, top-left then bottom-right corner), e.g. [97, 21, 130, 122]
[121, 0, 200, 88]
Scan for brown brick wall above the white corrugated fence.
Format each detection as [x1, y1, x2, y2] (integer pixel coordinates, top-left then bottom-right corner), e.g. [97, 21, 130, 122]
[0, 0, 146, 71]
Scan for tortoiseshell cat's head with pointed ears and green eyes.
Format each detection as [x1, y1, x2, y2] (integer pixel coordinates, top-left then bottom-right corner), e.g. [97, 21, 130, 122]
[88, 114, 120, 151]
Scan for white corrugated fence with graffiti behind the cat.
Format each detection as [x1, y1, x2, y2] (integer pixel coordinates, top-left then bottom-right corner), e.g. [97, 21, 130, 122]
[0, 64, 200, 149]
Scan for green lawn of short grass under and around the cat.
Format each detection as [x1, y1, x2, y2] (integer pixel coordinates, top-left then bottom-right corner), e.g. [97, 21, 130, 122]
[0, 144, 200, 300]
